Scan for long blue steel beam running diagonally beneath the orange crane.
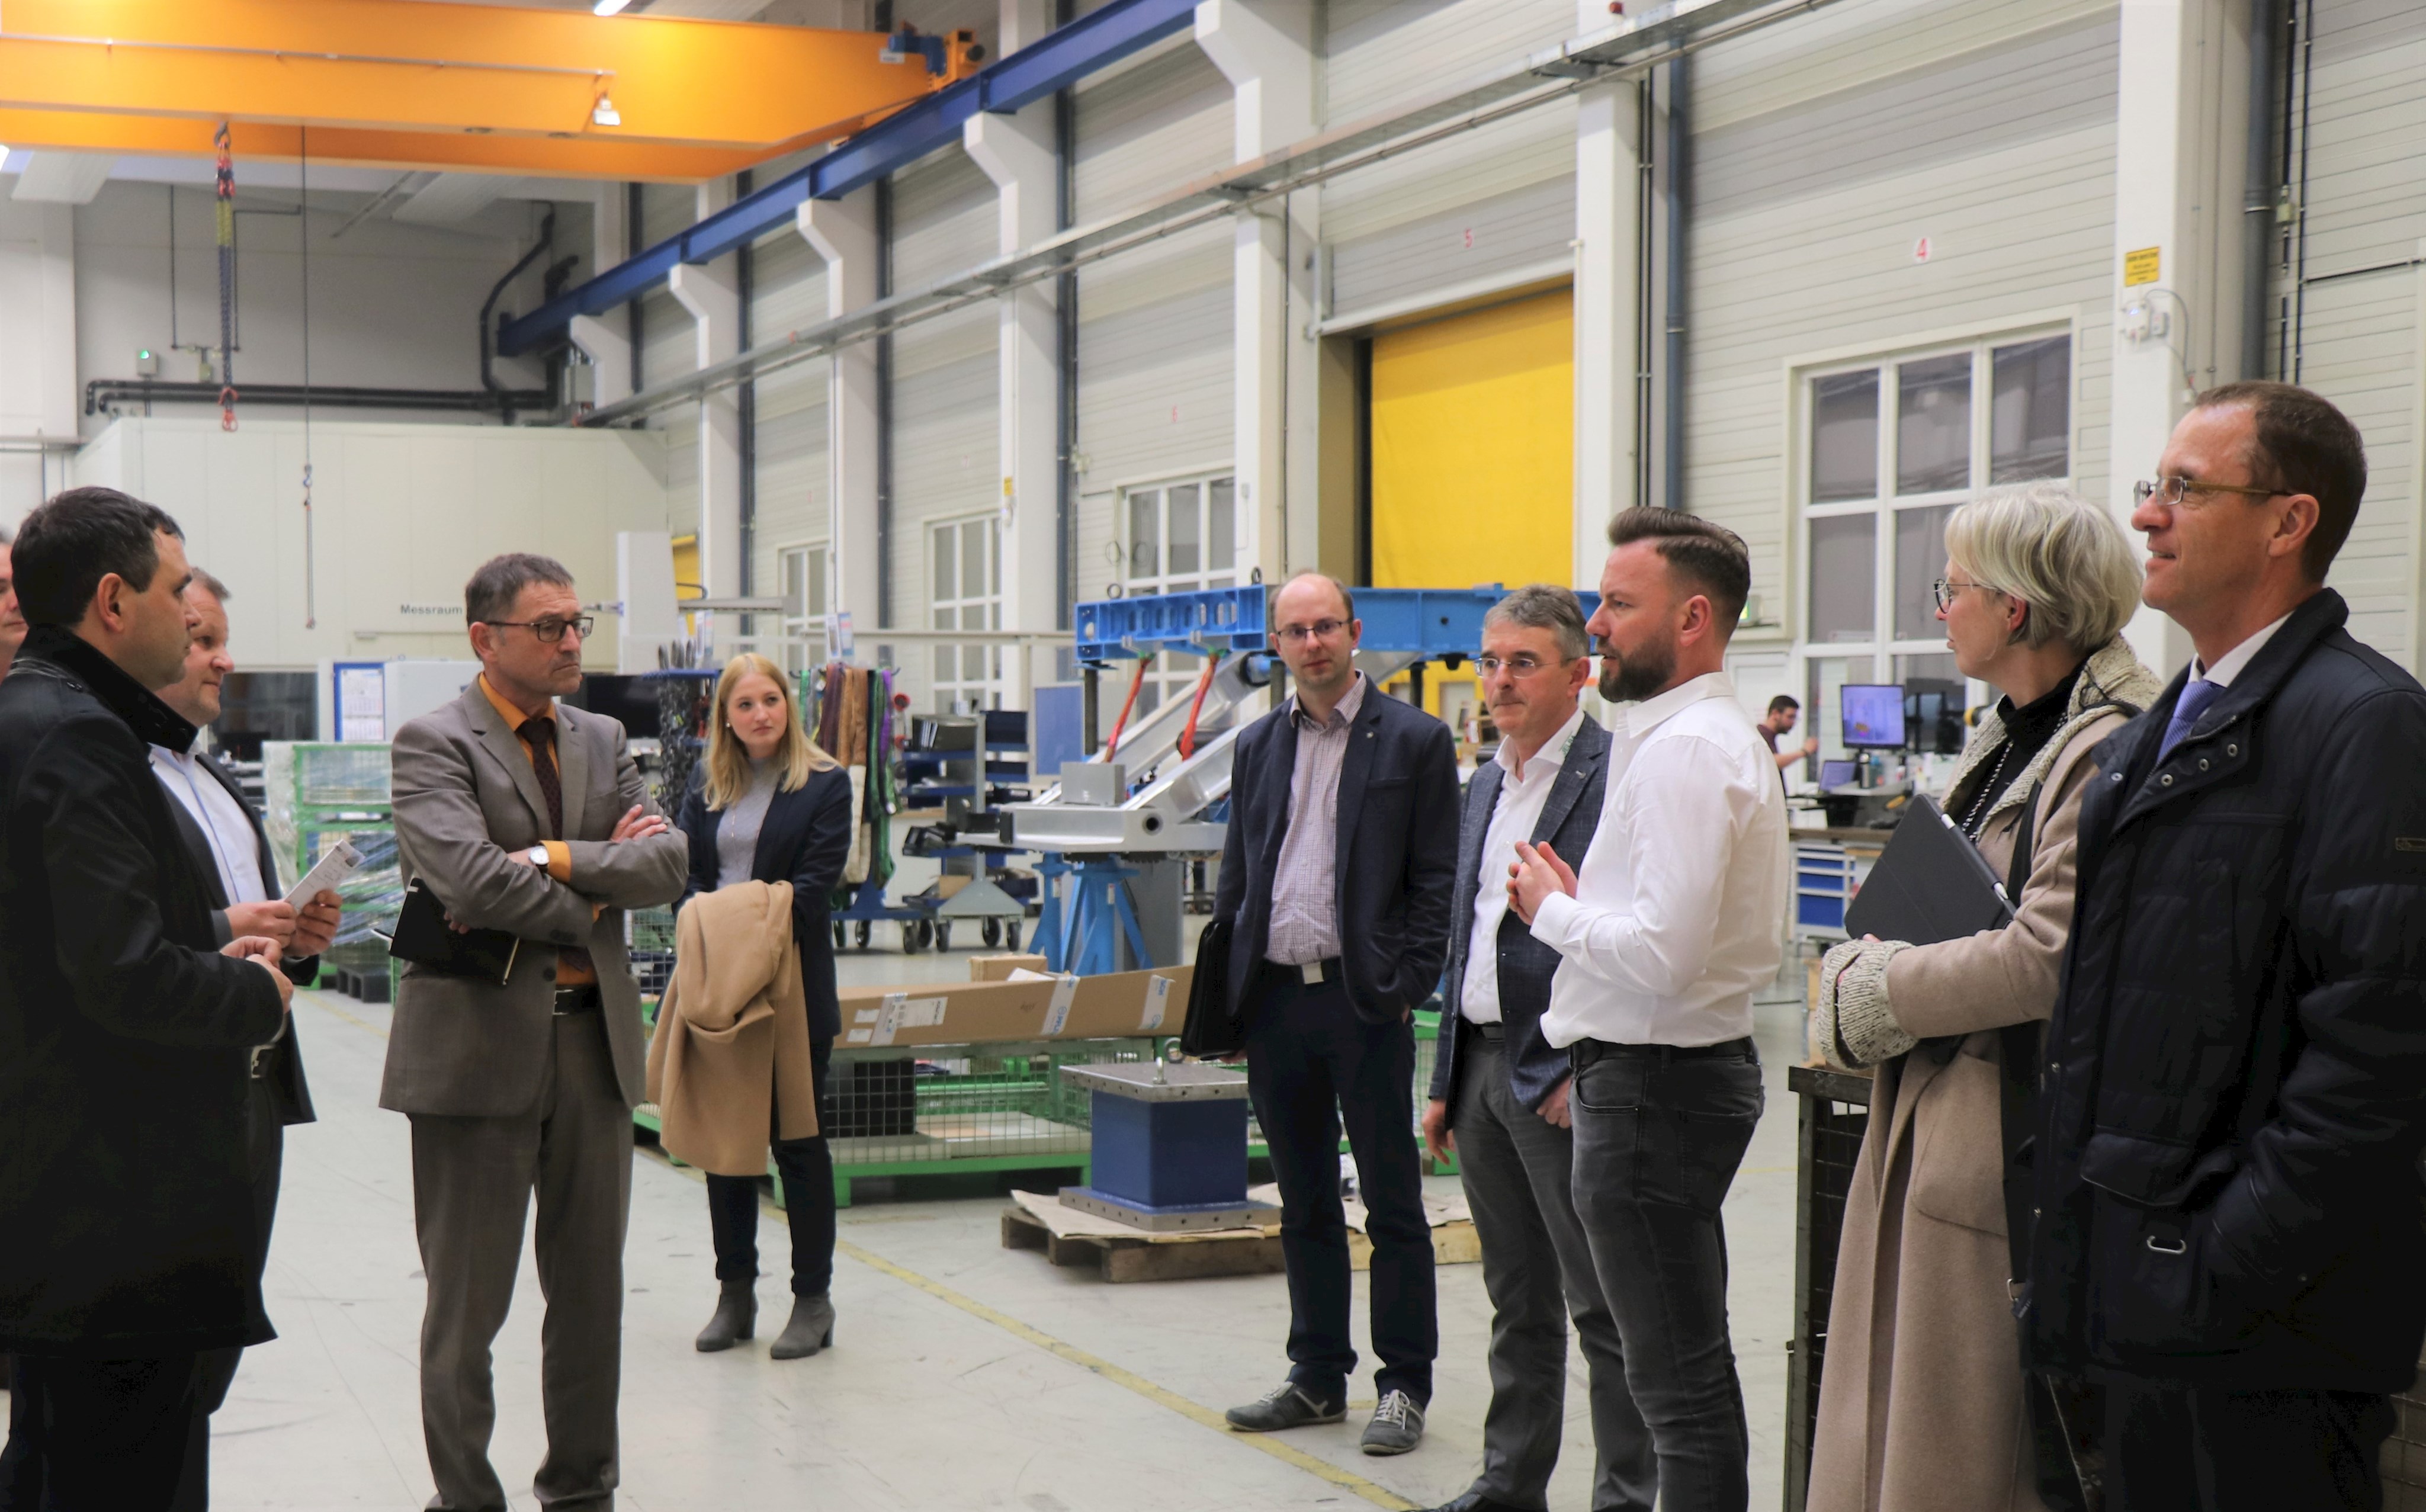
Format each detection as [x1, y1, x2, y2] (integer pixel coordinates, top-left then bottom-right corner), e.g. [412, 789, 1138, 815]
[498, 0, 1196, 357]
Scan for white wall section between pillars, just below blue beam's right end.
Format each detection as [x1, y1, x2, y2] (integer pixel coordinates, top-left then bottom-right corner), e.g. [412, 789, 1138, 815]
[1075, 39, 1233, 226]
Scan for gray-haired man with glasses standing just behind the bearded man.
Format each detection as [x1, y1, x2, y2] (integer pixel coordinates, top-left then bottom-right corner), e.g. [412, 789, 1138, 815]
[1424, 582, 1657, 1512]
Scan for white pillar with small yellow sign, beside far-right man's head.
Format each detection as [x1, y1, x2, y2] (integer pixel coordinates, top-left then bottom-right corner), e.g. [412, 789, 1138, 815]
[2106, 0, 2249, 672]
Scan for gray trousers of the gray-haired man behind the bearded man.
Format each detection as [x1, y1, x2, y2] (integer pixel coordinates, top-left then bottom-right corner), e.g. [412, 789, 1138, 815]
[1451, 1032, 1660, 1512]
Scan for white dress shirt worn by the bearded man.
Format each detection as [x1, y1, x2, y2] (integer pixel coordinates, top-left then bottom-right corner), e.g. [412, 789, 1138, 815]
[1533, 672, 1786, 1046]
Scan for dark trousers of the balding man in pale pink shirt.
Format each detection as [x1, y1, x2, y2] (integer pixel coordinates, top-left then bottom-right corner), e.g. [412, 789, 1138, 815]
[1247, 966, 1441, 1403]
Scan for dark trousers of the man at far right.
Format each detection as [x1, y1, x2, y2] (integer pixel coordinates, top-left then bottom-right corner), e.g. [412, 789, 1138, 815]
[2106, 1376, 2392, 1512]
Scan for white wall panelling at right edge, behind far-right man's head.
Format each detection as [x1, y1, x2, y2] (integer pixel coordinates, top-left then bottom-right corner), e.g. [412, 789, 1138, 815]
[2297, 0, 2426, 672]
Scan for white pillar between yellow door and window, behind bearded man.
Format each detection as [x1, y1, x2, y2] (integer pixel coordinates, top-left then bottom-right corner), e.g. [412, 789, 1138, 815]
[1574, 63, 1642, 588]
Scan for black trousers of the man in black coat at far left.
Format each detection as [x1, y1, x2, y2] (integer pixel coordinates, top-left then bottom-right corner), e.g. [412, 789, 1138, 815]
[0, 1354, 204, 1512]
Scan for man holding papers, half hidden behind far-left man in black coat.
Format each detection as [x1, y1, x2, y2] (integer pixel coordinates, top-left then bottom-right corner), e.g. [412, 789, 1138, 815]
[150, 568, 339, 1512]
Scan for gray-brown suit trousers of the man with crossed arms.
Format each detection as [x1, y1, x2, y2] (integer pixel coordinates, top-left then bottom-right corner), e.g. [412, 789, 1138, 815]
[412, 1012, 631, 1512]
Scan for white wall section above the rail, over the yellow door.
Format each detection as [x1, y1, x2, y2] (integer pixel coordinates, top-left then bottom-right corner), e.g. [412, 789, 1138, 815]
[1322, 0, 1577, 126]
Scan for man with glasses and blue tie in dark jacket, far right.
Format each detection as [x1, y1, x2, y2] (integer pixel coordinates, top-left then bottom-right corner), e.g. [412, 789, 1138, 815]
[2026, 383, 2426, 1512]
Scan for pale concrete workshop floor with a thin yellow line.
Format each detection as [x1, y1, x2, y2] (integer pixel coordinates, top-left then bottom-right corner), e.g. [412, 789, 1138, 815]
[104, 951, 1800, 1512]
